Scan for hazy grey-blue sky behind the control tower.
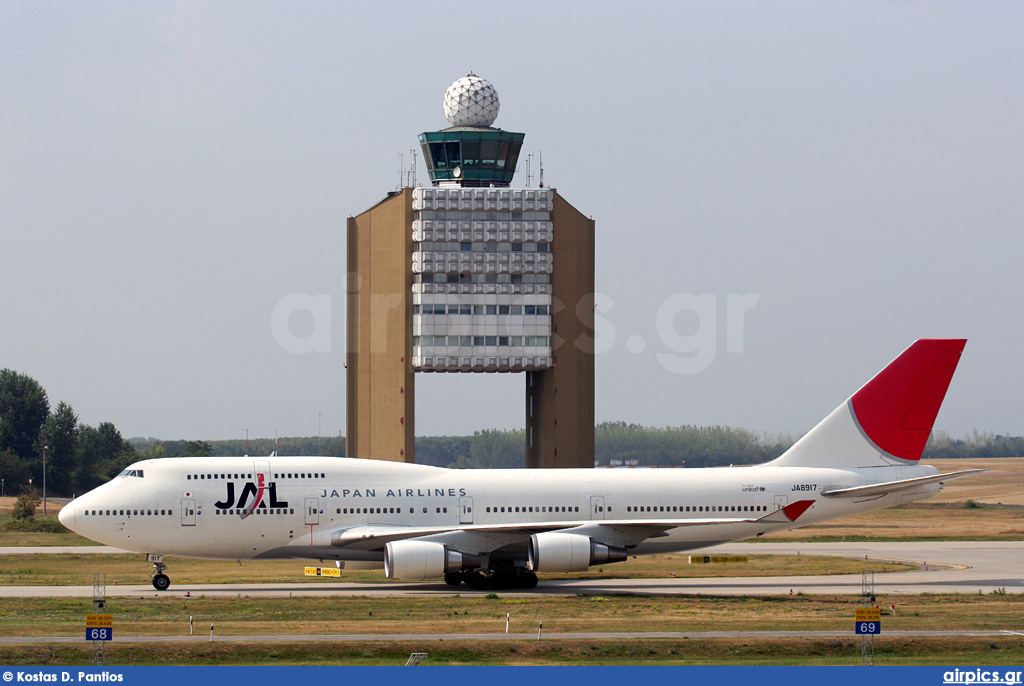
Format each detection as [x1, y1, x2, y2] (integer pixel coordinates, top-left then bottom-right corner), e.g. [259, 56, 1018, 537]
[0, 0, 1024, 439]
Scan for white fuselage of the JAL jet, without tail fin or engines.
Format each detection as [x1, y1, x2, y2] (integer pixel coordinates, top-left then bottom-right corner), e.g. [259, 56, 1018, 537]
[60, 457, 939, 561]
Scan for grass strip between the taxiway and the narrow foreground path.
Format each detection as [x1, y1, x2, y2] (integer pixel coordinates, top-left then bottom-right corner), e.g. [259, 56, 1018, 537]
[0, 592, 1024, 637]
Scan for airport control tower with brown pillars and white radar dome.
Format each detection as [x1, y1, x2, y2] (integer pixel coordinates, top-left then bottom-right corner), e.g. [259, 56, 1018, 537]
[346, 73, 594, 467]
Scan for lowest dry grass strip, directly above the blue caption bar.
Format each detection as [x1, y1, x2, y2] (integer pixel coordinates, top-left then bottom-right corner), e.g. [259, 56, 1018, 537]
[0, 637, 1024, 667]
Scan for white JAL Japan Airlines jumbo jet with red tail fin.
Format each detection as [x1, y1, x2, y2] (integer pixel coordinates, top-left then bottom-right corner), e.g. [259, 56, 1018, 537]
[59, 340, 981, 590]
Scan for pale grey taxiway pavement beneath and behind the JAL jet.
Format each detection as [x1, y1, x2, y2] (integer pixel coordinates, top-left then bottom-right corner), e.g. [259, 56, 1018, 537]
[0, 541, 1024, 598]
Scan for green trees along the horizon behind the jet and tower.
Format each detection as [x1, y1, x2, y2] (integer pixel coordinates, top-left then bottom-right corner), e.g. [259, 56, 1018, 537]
[0, 369, 1024, 496]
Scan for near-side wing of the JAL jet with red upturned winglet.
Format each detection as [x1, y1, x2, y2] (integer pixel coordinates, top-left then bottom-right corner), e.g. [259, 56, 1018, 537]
[331, 501, 814, 550]
